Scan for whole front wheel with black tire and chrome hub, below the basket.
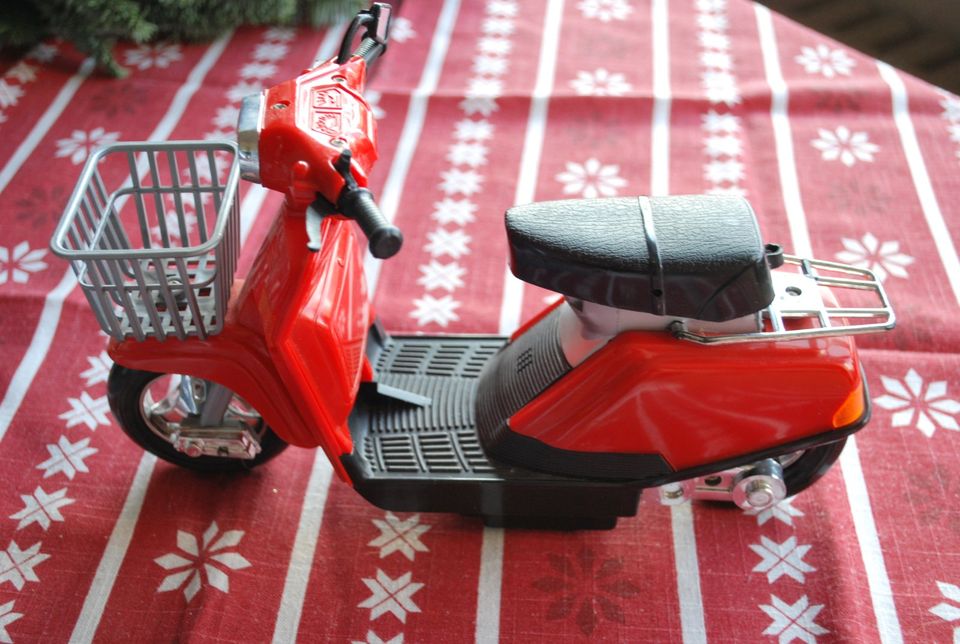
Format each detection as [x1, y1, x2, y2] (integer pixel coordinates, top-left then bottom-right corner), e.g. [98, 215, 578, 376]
[107, 364, 287, 472]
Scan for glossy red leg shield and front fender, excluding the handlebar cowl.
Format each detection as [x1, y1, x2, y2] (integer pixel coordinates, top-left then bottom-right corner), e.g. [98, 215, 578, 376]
[110, 204, 370, 479]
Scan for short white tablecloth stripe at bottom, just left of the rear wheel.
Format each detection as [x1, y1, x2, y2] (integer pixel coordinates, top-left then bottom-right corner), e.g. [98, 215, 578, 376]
[670, 503, 707, 644]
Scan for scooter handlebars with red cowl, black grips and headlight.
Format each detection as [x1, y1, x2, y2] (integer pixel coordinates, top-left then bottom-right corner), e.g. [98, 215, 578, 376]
[248, 2, 403, 259]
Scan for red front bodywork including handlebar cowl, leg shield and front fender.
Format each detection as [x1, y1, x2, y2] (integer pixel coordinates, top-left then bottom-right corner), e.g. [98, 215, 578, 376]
[110, 57, 377, 479]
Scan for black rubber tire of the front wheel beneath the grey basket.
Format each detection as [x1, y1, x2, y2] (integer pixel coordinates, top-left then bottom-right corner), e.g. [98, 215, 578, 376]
[107, 364, 287, 472]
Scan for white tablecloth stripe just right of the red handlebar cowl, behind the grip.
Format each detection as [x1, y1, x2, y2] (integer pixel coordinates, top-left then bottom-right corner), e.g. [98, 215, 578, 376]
[363, 0, 460, 299]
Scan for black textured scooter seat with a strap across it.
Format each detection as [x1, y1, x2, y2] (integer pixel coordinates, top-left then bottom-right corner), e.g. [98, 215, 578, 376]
[506, 195, 774, 322]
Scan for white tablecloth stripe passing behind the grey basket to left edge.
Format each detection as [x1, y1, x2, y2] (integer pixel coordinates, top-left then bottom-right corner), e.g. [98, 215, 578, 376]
[0, 32, 232, 448]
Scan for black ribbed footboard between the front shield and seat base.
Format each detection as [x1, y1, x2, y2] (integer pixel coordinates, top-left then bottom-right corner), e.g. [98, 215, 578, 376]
[343, 328, 640, 528]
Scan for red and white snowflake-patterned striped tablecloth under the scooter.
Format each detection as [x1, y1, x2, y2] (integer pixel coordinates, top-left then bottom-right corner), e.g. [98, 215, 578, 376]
[0, 0, 960, 644]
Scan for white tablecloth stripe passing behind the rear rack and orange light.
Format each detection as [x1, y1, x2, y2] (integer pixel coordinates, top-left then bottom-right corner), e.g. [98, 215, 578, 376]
[754, 5, 915, 644]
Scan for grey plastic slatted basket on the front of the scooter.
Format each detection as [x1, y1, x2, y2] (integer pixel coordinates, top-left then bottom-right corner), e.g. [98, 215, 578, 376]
[50, 141, 240, 341]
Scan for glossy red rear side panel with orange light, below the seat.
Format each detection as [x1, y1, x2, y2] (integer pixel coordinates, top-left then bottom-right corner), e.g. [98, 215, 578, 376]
[509, 331, 863, 471]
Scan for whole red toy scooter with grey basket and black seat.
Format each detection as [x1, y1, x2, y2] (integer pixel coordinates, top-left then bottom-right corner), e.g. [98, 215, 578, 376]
[52, 4, 894, 528]
